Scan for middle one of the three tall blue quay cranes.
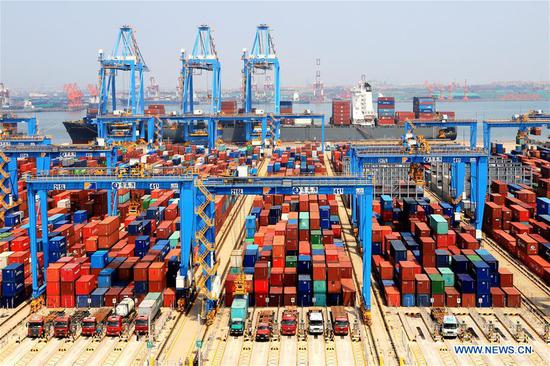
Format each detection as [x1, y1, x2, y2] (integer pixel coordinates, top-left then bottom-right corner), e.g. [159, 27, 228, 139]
[180, 25, 222, 114]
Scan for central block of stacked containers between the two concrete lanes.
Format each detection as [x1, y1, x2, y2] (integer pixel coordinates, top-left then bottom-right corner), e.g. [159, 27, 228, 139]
[225, 195, 356, 306]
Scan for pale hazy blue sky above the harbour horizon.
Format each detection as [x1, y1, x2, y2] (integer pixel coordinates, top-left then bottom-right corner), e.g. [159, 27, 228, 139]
[0, 0, 550, 90]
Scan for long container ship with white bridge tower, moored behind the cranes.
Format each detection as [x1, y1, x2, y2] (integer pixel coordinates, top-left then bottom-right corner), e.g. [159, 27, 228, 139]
[63, 80, 457, 144]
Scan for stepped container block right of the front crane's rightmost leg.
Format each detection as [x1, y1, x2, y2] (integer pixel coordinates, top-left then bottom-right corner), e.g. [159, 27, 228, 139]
[372, 195, 521, 307]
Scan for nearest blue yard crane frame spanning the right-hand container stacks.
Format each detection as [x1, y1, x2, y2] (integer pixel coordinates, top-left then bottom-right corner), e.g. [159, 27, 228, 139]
[349, 145, 489, 238]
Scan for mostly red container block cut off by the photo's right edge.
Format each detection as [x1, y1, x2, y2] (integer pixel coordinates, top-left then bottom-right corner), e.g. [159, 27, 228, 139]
[483, 181, 550, 284]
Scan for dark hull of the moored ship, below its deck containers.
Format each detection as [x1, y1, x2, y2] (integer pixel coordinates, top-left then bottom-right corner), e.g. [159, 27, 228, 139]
[63, 121, 456, 144]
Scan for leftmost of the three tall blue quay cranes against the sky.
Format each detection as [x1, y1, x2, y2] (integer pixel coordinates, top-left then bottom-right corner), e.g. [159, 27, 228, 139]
[98, 25, 149, 115]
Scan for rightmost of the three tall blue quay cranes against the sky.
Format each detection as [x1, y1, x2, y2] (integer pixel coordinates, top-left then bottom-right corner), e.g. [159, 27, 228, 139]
[242, 24, 281, 114]
